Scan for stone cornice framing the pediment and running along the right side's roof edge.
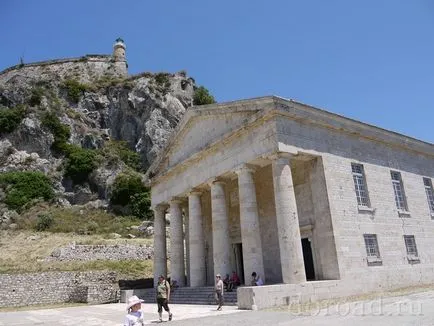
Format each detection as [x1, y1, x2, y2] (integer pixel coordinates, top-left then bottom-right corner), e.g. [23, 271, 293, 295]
[148, 96, 434, 185]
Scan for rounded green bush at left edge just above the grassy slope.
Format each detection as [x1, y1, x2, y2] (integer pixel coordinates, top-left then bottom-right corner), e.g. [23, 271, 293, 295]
[0, 171, 54, 211]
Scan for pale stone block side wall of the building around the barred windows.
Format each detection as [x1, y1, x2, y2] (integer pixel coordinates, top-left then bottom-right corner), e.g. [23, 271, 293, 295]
[277, 107, 434, 291]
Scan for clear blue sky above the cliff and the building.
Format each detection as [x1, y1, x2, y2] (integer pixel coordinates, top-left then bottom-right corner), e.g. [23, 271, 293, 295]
[0, 0, 434, 143]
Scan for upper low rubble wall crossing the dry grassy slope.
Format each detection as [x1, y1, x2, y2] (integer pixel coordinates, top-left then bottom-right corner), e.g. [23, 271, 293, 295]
[46, 244, 154, 261]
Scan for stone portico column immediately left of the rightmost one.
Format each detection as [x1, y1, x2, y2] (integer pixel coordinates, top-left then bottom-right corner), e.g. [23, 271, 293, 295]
[236, 166, 265, 285]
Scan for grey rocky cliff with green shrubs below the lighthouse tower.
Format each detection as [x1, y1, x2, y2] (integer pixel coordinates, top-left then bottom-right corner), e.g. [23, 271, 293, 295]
[0, 56, 196, 227]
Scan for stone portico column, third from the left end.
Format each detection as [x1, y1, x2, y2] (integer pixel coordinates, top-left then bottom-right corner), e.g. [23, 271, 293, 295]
[188, 192, 206, 287]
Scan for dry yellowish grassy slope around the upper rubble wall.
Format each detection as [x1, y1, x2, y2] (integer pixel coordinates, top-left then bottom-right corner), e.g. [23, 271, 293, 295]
[0, 230, 152, 278]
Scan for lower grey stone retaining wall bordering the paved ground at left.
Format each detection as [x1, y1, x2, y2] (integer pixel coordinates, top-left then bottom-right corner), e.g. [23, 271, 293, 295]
[0, 272, 119, 307]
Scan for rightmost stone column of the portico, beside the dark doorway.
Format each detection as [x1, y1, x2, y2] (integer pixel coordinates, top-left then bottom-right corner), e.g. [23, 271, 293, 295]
[270, 153, 306, 283]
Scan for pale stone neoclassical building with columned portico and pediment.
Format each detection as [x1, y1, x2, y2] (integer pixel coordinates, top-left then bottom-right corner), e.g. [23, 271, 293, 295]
[149, 97, 434, 308]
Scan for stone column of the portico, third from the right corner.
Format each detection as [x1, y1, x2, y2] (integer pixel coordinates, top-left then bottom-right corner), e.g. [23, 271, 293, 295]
[210, 180, 231, 277]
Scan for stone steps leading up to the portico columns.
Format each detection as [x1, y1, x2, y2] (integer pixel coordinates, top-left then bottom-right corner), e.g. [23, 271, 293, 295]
[137, 286, 237, 306]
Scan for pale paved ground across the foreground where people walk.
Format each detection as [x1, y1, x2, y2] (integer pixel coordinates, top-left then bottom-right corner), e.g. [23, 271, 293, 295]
[0, 291, 434, 326]
